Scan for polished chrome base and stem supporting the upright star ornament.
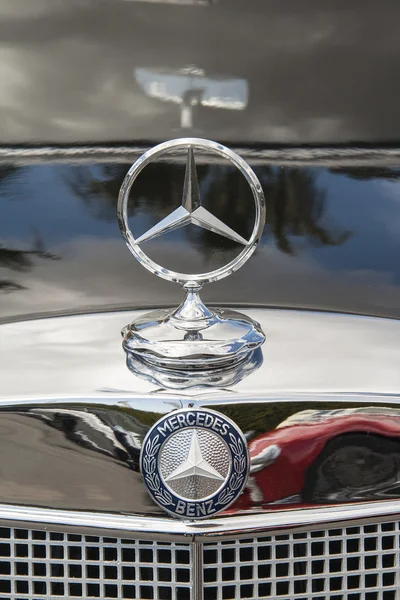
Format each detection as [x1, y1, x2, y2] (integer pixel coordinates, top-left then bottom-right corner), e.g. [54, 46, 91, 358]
[122, 291, 265, 371]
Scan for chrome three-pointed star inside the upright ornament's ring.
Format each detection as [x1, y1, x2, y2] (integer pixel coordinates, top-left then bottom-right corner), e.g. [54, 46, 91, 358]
[136, 148, 249, 246]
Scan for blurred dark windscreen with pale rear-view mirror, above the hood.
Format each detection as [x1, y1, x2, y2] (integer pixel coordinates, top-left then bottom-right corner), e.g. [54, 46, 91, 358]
[0, 0, 400, 144]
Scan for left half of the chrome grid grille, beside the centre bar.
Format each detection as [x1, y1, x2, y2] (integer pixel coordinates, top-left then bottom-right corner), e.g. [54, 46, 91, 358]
[0, 528, 192, 600]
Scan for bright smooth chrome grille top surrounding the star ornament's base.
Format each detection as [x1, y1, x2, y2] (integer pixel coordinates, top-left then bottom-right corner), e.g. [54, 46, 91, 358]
[0, 308, 400, 400]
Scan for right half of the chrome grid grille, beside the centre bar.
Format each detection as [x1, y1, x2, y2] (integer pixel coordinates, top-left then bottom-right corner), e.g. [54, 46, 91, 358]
[204, 522, 400, 600]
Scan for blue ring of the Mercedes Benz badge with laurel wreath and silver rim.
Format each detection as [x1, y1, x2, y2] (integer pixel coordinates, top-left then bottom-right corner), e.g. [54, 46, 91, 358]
[139, 408, 250, 521]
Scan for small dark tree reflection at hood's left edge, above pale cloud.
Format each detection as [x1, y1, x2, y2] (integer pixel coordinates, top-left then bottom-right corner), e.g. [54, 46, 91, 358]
[0, 237, 59, 292]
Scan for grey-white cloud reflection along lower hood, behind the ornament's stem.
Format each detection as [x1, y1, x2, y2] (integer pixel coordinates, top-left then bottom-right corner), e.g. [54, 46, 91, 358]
[0, 238, 400, 317]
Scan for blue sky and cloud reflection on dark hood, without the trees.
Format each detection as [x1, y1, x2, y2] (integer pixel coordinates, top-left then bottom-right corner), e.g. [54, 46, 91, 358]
[0, 164, 400, 316]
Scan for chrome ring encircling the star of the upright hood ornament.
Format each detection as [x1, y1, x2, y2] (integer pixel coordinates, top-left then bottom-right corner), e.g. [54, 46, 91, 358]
[117, 138, 266, 287]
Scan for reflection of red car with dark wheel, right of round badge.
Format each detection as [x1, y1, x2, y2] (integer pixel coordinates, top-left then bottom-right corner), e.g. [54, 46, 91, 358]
[242, 407, 400, 506]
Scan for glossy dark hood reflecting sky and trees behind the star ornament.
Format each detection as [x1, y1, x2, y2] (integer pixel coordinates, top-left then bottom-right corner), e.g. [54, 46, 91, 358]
[0, 162, 400, 320]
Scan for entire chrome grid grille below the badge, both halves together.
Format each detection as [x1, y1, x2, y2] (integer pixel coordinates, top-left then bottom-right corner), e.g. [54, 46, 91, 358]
[0, 519, 400, 600]
